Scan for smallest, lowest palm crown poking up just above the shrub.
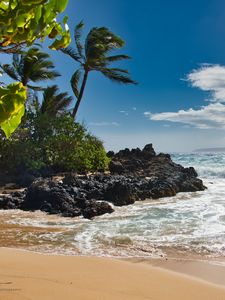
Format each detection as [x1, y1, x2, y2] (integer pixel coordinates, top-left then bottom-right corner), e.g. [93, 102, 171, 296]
[40, 85, 73, 117]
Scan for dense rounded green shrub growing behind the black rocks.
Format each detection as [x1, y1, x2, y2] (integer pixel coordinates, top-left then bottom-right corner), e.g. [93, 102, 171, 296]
[0, 112, 109, 173]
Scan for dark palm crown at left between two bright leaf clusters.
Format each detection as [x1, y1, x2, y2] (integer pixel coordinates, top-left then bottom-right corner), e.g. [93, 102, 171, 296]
[0, 47, 60, 90]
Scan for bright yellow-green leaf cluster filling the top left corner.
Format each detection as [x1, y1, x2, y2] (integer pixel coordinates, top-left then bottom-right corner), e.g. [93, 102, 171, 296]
[0, 0, 70, 53]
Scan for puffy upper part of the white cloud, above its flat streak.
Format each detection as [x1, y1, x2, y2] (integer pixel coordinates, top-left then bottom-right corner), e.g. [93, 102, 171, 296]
[187, 64, 225, 102]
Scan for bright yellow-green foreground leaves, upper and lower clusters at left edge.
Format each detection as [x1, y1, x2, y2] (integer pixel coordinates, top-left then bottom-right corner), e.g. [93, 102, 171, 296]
[0, 0, 71, 136]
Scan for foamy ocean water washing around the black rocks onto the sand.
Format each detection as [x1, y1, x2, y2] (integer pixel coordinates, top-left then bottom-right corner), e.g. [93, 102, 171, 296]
[0, 153, 225, 258]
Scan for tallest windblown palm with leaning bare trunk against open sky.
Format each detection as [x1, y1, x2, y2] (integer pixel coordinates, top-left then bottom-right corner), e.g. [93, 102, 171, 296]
[61, 22, 136, 119]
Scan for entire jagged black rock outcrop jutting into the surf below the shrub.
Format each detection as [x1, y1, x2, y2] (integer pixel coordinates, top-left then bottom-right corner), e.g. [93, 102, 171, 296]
[0, 144, 205, 219]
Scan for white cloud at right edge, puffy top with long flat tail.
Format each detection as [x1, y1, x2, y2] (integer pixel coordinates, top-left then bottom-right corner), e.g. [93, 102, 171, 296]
[144, 64, 225, 129]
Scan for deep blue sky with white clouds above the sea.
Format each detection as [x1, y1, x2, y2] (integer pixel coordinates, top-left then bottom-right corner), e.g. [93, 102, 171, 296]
[3, 0, 225, 152]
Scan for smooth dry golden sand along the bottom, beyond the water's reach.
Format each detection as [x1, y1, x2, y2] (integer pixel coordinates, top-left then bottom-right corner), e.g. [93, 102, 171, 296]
[0, 248, 225, 300]
